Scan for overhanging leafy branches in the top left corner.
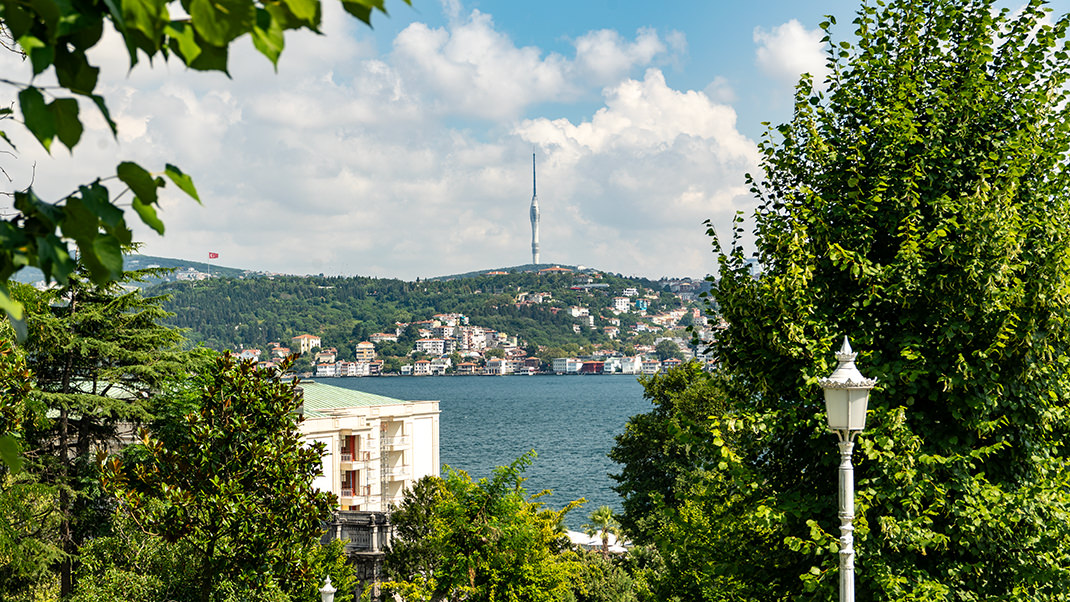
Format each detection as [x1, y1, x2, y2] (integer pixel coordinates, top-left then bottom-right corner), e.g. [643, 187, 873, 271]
[0, 0, 410, 324]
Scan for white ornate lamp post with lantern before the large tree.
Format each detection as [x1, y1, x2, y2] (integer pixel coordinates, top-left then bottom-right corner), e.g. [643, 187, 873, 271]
[817, 337, 876, 602]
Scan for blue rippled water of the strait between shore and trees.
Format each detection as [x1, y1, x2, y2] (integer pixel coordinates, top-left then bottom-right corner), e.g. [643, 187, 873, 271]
[320, 375, 652, 528]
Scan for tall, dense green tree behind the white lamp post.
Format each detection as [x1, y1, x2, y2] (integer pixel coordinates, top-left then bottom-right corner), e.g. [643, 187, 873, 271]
[624, 0, 1070, 600]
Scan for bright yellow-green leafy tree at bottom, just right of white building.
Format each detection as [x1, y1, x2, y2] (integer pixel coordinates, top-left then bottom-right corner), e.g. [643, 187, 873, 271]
[384, 452, 582, 602]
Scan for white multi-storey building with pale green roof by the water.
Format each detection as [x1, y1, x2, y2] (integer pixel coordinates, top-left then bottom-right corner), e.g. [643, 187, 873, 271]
[300, 381, 440, 511]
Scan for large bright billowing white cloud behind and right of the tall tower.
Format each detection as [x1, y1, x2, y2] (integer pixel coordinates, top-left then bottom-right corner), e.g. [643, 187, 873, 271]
[517, 70, 758, 274]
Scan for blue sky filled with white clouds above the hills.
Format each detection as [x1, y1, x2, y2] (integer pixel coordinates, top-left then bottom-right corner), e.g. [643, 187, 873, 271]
[0, 0, 1070, 280]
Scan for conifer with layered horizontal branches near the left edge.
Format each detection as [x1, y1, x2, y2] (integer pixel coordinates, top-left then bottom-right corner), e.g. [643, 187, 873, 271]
[12, 267, 189, 595]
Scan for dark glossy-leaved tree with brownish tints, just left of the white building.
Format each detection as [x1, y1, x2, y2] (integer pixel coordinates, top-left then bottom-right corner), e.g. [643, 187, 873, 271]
[103, 353, 335, 602]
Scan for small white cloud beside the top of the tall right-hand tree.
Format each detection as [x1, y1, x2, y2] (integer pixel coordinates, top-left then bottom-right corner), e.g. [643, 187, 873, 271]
[754, 19, 828, 86]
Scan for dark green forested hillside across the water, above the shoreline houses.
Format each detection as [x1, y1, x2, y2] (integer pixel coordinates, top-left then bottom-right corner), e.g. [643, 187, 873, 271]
[151, 268, 679, 356]
